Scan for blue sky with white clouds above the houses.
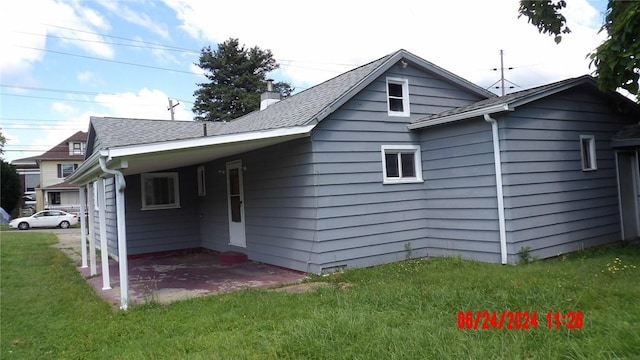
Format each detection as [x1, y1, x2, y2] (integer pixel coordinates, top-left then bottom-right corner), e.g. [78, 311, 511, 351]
[0, 0, 607, 162]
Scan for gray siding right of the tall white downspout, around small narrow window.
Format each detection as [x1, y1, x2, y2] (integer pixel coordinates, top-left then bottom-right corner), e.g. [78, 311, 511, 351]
[499, 89, 633, 261]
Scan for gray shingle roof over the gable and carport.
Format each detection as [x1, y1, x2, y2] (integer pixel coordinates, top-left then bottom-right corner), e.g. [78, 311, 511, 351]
[90, 50, 495, 148]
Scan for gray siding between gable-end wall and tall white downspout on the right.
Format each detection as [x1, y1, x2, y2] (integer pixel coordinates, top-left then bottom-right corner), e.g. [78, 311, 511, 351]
[420, 119, 500, 262]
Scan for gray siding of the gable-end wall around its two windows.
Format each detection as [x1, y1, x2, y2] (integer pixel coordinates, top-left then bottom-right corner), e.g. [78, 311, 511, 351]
[312, 63, 478, 271]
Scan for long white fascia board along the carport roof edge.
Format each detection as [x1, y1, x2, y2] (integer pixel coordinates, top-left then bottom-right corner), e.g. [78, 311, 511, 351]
[100, 124, 316, 161]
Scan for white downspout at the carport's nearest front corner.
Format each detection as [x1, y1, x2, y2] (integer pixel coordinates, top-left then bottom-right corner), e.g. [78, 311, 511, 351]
[99, 156, 129, 310]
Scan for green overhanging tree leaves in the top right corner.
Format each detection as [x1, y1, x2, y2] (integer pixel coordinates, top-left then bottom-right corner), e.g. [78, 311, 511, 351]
[519, 0, 640, 101]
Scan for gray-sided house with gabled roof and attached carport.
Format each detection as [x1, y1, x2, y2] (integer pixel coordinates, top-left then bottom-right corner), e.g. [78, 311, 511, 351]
[68, 50, 640, 308]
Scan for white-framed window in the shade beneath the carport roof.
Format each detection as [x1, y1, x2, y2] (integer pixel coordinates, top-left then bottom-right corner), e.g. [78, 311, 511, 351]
[141, 172, 180, 210]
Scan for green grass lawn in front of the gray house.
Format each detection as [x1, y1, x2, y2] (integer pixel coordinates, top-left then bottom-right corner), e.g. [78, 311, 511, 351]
[0, 232, 640, 360]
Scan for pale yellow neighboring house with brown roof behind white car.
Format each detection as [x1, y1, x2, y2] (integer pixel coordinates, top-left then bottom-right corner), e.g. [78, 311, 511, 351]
[29, 131, 87, 212]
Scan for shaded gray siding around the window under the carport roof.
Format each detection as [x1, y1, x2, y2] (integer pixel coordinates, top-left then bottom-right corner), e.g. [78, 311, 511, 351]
[125, 167, 200, 255]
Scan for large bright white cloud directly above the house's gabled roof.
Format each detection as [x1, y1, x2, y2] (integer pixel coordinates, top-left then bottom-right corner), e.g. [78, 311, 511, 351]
[165, 0, 601, 93]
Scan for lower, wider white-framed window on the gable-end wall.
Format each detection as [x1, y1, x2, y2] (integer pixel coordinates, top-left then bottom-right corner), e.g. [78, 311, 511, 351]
[380, 145, 423, 184]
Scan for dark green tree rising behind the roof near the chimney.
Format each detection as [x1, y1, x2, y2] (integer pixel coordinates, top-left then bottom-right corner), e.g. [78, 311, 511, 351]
[193, 38, 293, 121]
